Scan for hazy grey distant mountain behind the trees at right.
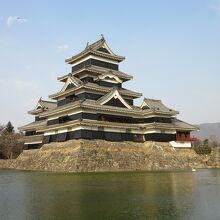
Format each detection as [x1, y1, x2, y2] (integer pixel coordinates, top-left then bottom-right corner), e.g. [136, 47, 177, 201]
[192, 122, 220, 143]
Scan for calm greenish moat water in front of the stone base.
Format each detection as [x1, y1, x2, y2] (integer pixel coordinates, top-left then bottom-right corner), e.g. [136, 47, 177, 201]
[0, 169, 220, 220]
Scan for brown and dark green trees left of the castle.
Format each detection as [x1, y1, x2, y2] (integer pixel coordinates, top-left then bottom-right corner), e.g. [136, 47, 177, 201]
[0, 121, 23, 159]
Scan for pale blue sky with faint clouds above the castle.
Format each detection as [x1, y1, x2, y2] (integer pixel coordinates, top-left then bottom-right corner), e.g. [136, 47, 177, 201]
[0, 0, 220, 127]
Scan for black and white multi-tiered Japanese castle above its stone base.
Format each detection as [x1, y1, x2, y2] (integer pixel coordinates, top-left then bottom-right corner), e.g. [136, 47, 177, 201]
[19, 37, 198, 149]
